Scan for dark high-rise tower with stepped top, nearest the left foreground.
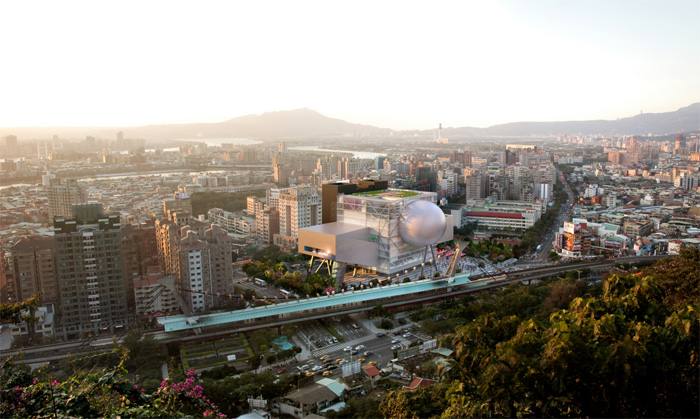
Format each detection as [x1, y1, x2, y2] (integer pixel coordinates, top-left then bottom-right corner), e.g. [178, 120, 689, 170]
[54, 204, 130, 337]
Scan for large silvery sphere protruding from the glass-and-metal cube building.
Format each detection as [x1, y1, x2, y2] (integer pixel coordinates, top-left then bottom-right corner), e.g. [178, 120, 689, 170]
[399, 199, 447, 246]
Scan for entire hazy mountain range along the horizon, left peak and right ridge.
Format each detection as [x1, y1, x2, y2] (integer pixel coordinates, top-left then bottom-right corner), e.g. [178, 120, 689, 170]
[0, 103, 700, 141]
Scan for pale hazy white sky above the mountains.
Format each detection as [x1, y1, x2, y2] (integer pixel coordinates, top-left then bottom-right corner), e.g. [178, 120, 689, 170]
[0, 0, 700, 128]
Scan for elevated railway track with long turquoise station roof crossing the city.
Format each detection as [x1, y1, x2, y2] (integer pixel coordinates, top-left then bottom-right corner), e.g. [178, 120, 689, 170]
[0, 256, 667, 363]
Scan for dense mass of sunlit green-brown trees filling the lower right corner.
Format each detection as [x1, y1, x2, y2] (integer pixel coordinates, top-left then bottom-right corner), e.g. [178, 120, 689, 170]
[381, 252, 700, 418]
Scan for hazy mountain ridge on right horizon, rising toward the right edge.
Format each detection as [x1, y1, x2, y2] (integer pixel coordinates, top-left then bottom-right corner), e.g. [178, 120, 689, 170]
[443, 103, 700, 138]
